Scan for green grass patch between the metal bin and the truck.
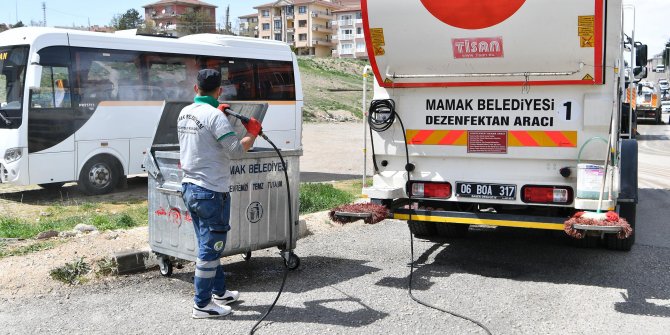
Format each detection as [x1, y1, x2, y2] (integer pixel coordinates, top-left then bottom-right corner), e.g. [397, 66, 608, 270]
[300, 183, 360, 214]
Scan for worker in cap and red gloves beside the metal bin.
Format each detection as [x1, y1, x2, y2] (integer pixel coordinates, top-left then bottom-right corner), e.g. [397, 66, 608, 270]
[177, 69, 261, 319]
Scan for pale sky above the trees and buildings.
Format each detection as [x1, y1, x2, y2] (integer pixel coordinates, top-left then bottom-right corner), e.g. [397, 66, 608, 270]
[0, 0, 670, 56]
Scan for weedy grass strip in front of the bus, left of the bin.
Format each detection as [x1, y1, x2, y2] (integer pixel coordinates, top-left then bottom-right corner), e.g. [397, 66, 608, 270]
[0, 204, 148, 238]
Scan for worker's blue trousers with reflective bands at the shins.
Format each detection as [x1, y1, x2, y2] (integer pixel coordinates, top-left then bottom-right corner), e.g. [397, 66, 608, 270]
[182, 183, 230, 307]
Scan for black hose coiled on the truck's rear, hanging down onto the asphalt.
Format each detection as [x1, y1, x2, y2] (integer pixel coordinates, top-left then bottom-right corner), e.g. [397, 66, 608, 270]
[368, 99, 492, 335]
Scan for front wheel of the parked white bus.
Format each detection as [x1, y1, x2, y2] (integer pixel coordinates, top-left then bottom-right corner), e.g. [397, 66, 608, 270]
[78, 156, 121, 195]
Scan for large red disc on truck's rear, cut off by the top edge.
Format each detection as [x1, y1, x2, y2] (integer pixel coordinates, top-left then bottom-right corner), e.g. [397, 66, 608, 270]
[421, 0, 526, 29]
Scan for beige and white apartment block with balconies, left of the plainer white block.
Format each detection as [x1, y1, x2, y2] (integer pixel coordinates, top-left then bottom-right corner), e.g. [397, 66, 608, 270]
[254, 0, 342, 57]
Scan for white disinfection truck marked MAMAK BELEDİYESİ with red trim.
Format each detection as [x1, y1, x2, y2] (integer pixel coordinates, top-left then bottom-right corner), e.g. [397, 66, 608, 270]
[362, 0, 647, 250]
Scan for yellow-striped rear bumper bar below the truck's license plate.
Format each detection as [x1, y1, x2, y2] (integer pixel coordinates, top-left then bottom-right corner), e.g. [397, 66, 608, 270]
[392, 208, 567, 230]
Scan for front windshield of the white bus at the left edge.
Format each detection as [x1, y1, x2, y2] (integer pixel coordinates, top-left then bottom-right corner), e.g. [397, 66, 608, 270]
[0, 46, 28, 128]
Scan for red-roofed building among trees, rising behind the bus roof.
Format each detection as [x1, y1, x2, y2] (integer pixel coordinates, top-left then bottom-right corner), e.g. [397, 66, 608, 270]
[142, 0, 217, 36]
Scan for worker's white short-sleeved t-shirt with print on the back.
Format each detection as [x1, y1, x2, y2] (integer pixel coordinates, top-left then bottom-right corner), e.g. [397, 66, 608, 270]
[177, 103, 237, 192]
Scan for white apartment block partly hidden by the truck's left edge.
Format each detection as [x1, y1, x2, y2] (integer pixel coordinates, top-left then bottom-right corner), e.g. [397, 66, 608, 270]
[332, 2, 368, 59]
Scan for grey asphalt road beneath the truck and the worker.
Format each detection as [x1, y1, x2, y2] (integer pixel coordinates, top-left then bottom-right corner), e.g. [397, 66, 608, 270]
[0, 121, 670, 334]
